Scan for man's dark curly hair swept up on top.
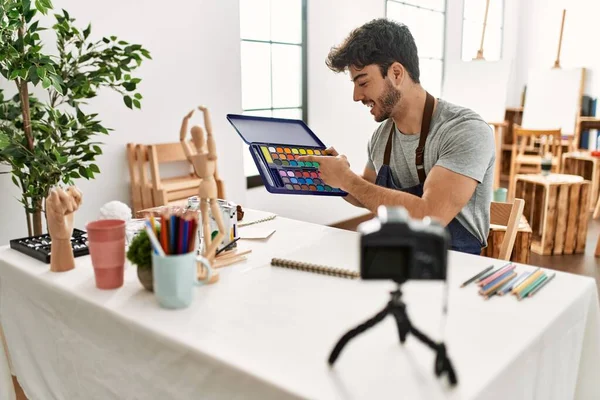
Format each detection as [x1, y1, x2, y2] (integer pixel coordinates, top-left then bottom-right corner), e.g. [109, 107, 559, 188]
[326, 18, 420, 83]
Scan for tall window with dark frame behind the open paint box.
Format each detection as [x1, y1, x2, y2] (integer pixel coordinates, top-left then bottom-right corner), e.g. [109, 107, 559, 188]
[240, 0, 307, 188]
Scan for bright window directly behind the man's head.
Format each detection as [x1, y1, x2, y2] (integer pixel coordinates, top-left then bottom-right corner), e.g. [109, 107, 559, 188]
[386, 0, 446, 96]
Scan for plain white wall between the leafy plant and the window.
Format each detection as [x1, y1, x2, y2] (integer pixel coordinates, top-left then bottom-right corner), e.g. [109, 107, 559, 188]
[0, 0, 245, 243]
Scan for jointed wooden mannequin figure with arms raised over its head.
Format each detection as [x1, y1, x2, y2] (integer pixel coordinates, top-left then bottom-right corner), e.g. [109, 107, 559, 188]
[179, 106, 225, 264]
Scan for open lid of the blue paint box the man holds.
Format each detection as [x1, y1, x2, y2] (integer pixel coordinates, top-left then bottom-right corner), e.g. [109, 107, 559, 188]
[227, 114, 325, 148]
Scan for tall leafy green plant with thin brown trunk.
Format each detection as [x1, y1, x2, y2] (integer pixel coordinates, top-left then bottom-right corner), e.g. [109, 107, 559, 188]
[0, 0, 150, 236]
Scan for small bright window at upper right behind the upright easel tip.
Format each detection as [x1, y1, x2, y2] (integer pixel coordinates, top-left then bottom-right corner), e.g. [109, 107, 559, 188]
[462, 0, 504, 61]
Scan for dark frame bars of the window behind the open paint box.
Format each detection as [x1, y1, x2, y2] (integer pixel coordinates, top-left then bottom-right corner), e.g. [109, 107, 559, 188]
[240, 0, 308, 189]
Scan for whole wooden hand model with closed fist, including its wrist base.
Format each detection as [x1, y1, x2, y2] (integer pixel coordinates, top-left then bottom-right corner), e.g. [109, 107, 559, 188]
[46, 186, 81, 272]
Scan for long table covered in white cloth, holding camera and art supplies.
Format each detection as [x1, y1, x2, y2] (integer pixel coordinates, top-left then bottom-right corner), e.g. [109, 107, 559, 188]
[0, 212, 600, 400]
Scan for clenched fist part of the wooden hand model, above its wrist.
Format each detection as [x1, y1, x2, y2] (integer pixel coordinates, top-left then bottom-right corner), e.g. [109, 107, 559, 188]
[46, 186, 81, 240]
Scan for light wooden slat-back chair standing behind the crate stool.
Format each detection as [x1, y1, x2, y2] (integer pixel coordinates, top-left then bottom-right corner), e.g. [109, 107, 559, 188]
[508, 125, 562, 200]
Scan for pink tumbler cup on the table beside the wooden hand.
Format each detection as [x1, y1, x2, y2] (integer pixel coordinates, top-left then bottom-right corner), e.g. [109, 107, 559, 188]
[86, 219, 125, 289]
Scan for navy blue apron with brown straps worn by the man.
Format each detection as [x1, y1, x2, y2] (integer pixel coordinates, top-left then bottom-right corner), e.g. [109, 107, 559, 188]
[375, 93, 482, 255]
